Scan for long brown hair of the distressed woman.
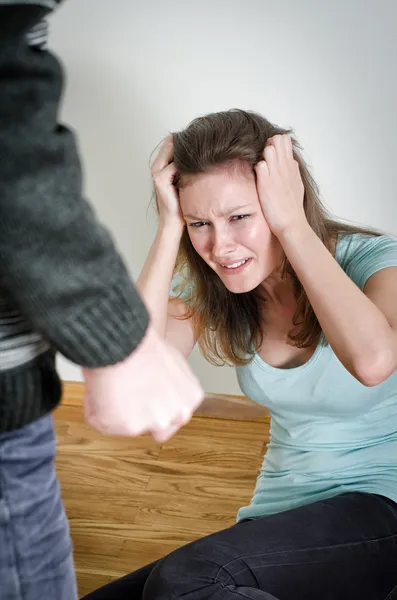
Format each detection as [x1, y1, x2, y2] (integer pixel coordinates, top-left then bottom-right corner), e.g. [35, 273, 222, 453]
[160, 109, 380, 365]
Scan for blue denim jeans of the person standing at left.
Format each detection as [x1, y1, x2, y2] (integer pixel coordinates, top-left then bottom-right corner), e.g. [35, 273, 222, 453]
[0, 415, 77, 600]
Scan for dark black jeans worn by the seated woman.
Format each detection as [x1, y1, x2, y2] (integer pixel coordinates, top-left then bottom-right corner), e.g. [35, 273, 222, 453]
[84, 493, 397, 600]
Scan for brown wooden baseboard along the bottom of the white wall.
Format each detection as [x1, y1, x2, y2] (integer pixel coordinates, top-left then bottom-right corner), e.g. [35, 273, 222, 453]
[62, 381, 269, 422]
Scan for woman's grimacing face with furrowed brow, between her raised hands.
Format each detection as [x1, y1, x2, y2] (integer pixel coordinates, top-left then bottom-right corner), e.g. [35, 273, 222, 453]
[179, 162, 283, 294]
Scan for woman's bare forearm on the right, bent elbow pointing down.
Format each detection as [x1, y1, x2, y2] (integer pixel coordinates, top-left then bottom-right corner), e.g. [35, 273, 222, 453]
[280, 223, 394, 380]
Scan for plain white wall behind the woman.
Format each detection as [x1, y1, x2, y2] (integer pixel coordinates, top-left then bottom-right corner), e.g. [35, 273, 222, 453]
[51, 0, 397, 394]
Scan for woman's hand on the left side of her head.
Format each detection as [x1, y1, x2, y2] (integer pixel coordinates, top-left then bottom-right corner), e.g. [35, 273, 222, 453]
[151, 135, 185, 230]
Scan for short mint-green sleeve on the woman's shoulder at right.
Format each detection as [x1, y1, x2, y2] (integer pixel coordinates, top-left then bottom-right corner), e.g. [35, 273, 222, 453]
[337, 234, 397, 290]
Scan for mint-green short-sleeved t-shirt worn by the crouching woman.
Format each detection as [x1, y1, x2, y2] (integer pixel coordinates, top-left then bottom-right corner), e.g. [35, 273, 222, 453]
[171, 234, 397, 521]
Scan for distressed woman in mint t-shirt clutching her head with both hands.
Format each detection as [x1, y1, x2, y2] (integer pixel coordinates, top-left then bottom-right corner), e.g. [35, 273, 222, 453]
[83, 110, 397, 600]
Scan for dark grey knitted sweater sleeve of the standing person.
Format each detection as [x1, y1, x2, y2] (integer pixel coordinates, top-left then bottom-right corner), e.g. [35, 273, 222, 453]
[0, 5, 148, 367]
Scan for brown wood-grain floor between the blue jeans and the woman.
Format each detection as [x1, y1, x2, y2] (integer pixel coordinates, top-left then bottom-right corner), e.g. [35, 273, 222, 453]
[55, 387, 269, 596]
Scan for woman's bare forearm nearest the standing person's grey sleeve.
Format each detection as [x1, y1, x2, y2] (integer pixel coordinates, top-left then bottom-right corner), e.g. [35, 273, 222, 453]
[137, 222, 182, 337]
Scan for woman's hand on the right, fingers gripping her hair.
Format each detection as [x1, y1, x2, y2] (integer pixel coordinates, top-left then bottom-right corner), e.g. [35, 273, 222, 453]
[255, 134, 307, 237]
